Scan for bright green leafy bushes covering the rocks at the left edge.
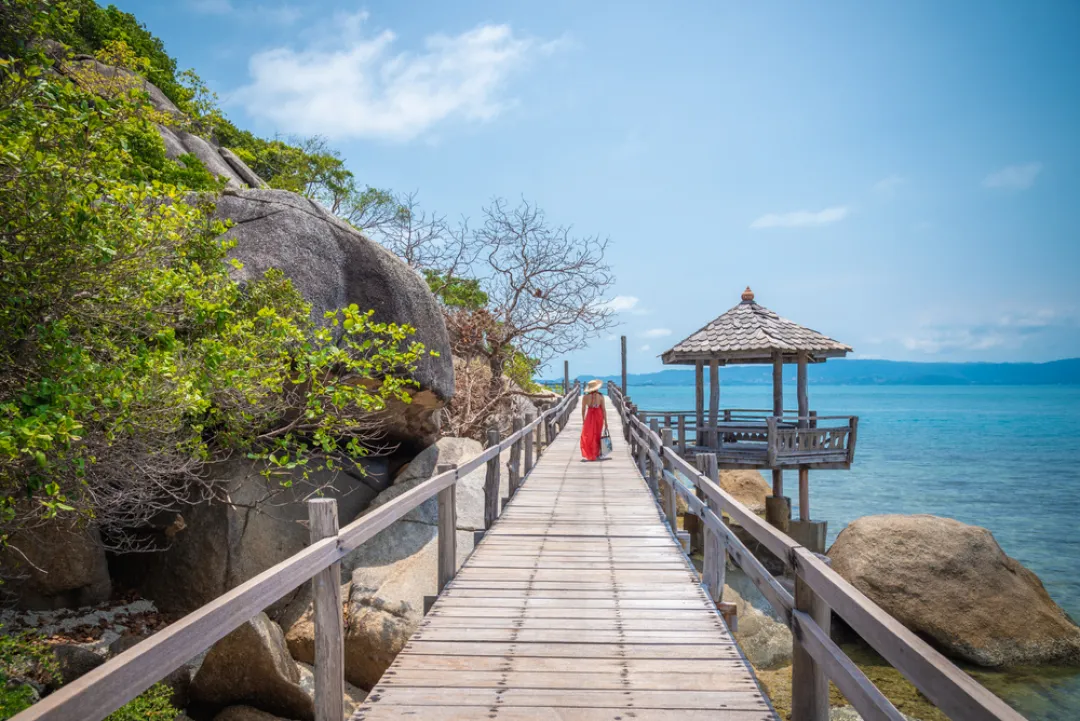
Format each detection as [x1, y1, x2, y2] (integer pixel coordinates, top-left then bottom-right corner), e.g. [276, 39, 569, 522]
[0, 26, 426, 540]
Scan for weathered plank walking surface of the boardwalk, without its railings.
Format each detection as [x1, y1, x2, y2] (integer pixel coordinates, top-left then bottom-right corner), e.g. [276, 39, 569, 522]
[353, 409, 777, 721]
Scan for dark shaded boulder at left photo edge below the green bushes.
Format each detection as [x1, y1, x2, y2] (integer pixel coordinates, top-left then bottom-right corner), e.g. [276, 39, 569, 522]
[0, 520, 112, 610]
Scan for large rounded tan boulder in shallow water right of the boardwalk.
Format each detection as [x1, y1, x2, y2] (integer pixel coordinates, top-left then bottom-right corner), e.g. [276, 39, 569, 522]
[828, 515, 1080, 667]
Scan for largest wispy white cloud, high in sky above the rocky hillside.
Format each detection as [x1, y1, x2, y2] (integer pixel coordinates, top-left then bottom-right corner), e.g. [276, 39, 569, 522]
[234, 12, 561, 141]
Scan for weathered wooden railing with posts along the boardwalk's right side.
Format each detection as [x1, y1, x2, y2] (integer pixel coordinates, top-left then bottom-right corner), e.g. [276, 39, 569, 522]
[608, 383, 1024, 721]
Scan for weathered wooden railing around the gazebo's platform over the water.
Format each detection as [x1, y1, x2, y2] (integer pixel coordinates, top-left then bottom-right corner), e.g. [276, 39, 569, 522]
[637, 408, 859, 467]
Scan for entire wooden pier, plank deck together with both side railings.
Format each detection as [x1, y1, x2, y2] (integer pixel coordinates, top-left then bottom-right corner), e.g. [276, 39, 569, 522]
[14, 371, 1023, 721]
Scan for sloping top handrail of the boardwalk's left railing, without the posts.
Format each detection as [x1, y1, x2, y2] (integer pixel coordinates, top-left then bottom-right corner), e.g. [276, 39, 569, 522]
[12, 383, 581, 721]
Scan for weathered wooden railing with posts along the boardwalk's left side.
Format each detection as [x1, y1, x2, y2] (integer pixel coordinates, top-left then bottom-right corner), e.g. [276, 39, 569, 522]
[13, 384, 580, 721]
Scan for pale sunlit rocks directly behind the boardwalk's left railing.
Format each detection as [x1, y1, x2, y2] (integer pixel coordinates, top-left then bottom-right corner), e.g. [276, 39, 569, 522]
[281, 438, 485, 689]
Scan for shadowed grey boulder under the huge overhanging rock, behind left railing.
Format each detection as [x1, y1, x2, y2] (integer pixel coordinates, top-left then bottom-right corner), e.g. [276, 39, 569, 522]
[112, 459, 388, 613]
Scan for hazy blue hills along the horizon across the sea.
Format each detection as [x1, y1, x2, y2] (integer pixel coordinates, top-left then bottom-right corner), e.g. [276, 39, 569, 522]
[565, 358, 1080, 385]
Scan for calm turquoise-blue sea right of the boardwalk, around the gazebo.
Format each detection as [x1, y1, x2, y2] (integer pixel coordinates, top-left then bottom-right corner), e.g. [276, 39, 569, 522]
[627, 384, 1080, 721]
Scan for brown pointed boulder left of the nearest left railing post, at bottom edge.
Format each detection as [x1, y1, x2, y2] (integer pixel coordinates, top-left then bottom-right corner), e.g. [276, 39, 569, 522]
[191, 613, 315, 721]
